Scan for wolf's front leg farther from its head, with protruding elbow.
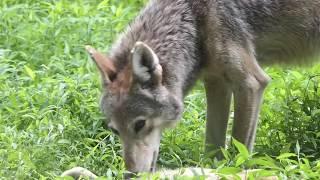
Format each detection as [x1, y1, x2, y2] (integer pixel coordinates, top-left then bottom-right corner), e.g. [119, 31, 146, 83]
[232, 55, 270, 151]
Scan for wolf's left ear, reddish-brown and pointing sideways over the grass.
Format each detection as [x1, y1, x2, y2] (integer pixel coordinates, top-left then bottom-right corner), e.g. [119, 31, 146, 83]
[85, 46, 116, 85]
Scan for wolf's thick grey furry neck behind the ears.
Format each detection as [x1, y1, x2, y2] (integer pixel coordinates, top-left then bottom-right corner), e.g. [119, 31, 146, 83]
[111, 0, 205, 98]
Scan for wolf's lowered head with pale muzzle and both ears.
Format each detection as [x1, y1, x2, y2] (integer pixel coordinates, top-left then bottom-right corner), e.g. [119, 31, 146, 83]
[86, 42, 183, 172]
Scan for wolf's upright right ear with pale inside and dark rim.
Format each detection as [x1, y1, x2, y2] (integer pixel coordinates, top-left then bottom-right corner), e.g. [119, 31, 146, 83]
[131, 42, 162, 85]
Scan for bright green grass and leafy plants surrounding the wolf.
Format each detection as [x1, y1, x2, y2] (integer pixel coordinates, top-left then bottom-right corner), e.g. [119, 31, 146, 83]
[0, 0, 320, 179]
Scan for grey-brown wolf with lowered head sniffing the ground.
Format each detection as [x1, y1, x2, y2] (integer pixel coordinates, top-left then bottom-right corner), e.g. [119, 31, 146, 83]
[69, 0, 320, 177]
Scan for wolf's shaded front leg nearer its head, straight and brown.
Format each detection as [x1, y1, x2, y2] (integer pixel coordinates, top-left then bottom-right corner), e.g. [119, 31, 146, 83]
[204, 77, 232, 159]
